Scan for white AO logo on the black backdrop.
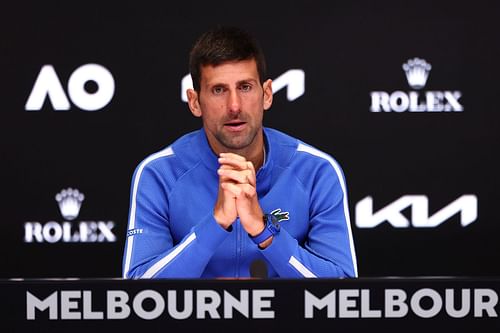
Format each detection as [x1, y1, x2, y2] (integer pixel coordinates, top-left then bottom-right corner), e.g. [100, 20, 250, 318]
[25, 64, 115, 111]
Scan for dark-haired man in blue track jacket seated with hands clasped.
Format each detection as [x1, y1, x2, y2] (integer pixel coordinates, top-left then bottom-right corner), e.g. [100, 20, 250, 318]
[123, 27, 357, 278]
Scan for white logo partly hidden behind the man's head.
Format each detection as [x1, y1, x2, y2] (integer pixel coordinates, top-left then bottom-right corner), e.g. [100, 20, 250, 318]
[181, 69, 306, 102]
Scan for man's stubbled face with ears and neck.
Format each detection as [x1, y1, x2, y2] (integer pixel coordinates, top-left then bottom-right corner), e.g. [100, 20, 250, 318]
[188, 59, 272, 153]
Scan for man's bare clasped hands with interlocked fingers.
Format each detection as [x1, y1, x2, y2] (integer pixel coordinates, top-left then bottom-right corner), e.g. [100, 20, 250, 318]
[214, 153, 265, 236]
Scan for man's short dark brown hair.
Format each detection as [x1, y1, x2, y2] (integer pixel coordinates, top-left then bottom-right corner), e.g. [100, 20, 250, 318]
[189, 26, 266, 92]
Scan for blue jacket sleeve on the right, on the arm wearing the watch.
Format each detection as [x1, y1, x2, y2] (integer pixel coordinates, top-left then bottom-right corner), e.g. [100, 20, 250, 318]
[262, 151, 357, 278]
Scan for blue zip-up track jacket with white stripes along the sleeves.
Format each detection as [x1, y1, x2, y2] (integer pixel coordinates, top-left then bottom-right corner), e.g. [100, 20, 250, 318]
[123, 128, 357, 278]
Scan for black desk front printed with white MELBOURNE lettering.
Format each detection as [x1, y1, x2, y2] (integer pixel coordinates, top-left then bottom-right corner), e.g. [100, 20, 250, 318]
[0, 277, 500, 333]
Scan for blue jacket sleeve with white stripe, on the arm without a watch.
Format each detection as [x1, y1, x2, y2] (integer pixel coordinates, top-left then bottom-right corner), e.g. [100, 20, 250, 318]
[123, 156, 230, 278]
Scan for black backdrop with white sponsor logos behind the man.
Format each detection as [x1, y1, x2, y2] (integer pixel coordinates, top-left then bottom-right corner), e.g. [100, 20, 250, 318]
[0, 1, 500, 278]
